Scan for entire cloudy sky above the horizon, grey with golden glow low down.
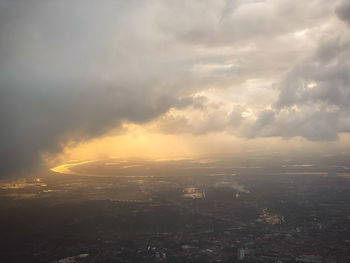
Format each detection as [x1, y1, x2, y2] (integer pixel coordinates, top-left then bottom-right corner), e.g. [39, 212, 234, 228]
[0, 0, 350, 178]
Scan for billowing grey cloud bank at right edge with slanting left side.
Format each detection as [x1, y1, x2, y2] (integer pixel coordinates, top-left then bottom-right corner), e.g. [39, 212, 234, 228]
[245, 32, 350, 141]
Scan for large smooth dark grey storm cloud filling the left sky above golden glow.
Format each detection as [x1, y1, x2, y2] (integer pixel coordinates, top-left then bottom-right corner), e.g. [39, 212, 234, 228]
[0, 1, 196, 177]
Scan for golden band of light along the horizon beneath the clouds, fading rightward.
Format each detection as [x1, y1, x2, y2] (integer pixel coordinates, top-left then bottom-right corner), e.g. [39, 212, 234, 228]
[47, 124, 349, 175]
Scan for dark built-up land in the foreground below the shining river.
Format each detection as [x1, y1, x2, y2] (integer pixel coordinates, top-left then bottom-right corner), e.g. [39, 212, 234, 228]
[0, 160, 350, 263]
